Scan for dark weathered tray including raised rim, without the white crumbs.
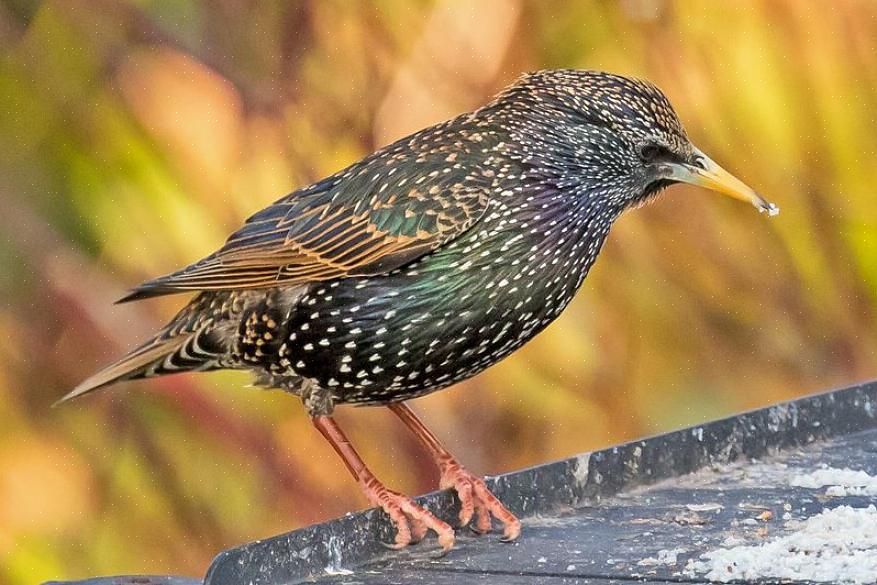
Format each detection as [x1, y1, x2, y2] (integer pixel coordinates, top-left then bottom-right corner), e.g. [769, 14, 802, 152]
[44, 382, 877, 585]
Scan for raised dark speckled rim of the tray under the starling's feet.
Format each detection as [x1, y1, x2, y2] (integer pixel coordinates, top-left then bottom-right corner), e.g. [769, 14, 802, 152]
[206, 383, 877, 585]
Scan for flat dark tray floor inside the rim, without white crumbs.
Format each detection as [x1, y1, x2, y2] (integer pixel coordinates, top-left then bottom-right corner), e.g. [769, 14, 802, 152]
[318, 429, 877, 585]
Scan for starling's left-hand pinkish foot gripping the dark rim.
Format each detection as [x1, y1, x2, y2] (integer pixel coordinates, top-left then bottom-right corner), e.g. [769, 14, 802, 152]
[360, 476, 455, 554]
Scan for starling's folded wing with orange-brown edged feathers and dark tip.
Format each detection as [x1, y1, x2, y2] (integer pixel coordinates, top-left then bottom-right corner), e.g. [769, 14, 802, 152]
[122, 147, 491, 301]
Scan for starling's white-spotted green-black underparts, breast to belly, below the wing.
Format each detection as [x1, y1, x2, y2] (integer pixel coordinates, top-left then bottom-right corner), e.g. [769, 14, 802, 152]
[272, 192, 608, 403]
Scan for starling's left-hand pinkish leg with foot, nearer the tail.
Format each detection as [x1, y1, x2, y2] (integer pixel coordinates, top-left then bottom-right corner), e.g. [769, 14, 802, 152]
[311, 416, 454, 551]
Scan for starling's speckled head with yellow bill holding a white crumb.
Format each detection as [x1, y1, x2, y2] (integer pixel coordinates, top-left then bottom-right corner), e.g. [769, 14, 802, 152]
[492, 69, 779, 215]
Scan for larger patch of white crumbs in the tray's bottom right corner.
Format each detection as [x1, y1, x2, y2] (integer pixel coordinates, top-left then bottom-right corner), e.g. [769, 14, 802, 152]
[685, 505, 877, 585]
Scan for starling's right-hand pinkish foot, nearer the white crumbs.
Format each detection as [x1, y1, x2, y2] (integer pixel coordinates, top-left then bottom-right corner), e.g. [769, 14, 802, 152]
[438, 456, 521, 542]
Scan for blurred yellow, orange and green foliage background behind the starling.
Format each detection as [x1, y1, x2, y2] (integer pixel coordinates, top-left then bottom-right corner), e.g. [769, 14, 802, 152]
[0, 0, 877, 584]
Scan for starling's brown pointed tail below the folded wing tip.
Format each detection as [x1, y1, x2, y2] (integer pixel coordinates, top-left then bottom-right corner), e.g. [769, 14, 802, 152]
[55, 292, 234, 405]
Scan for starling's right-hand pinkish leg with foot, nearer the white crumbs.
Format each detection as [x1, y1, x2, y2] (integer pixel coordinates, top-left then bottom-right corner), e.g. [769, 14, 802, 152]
[388, 402, 521, 541]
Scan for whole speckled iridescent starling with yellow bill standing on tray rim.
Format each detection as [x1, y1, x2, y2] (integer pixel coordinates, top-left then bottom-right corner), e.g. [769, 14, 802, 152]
[65, 70, 778, 550]
